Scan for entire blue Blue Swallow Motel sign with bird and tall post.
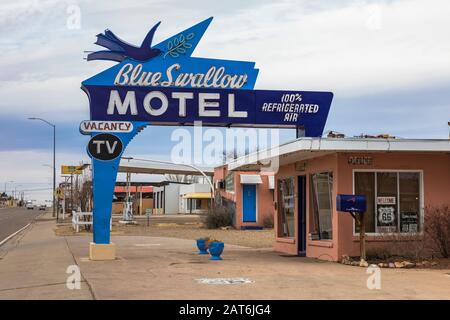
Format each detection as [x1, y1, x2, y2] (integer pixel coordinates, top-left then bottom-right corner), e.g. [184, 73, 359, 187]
[80, 17, 333, 248]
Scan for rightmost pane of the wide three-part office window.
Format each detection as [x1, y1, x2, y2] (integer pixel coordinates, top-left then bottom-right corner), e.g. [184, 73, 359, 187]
[399, 172, 420, 232]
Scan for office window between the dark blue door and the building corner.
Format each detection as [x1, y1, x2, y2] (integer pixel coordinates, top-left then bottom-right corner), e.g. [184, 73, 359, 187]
[311, 172, 333, 239]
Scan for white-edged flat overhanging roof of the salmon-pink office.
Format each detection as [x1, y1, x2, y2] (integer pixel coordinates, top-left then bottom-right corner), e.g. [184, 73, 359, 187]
[227, 138, 450, 171]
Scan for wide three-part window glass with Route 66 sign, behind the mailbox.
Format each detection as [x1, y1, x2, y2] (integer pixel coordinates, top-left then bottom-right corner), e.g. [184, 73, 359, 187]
[354, 172, 421, 233]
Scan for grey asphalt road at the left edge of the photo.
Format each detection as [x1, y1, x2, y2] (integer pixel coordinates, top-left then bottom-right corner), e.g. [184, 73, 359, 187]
[0, 207, 44, 242]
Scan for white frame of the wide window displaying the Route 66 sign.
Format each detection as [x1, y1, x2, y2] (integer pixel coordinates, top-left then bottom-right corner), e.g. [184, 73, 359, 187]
[352, 169, 425, 236]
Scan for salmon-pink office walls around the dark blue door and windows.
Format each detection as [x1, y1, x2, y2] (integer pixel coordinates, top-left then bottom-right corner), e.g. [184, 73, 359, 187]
[274, 152, 450, 261]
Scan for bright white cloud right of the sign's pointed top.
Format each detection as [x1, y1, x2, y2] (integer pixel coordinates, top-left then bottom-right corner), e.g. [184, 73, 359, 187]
[200, 0, 450, 95]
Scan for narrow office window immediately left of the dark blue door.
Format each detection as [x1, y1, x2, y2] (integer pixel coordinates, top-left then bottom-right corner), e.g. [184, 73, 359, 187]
[278, 178, 295, 237]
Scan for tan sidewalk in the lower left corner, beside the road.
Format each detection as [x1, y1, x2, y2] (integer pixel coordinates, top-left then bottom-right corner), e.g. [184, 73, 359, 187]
[0, 213, 93, 299]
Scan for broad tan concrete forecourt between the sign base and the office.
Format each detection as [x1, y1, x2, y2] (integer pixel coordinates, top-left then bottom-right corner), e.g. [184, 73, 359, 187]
[67, 236, 450, 300]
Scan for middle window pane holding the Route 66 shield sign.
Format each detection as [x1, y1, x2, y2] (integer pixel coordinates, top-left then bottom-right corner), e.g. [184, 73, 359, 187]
[376, 172, 398, 233]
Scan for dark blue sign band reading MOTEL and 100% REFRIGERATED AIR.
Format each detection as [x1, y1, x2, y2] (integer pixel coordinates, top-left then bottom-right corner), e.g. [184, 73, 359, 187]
[87, 86, 332, 135]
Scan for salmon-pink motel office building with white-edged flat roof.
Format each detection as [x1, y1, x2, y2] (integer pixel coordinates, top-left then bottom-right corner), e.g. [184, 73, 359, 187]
[228, 138, 450, 261]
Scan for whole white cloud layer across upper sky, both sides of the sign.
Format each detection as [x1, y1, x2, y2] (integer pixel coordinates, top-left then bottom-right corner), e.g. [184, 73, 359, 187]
[0, 0, 450, 118]
